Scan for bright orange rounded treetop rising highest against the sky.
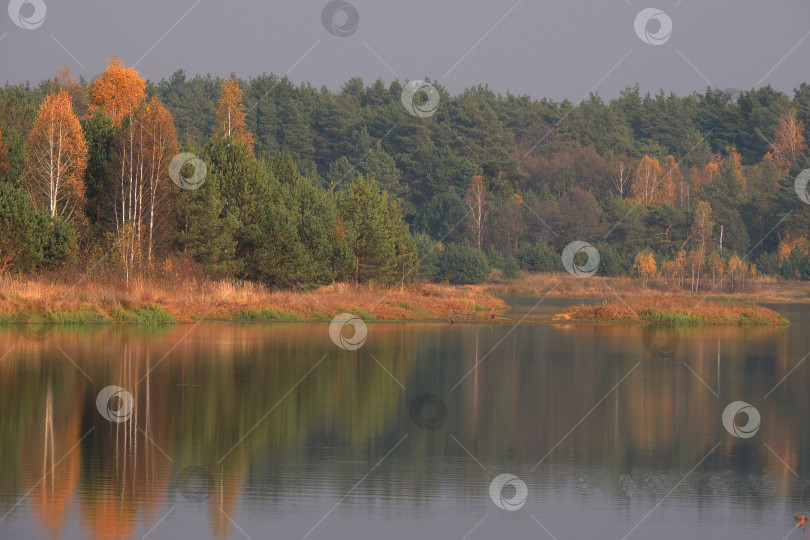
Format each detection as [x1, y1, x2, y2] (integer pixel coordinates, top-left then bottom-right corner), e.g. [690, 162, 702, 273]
[87, 57, 146, 124]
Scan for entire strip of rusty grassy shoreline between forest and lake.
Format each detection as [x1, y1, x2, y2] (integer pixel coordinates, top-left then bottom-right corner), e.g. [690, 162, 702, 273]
[0, 274, 796, 327]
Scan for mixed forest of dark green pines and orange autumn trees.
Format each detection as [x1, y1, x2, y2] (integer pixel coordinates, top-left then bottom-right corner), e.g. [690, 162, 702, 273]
[0, 58, 810, 292]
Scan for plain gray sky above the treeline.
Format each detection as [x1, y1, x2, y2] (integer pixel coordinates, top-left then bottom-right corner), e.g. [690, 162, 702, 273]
[0, 0, 810, 102]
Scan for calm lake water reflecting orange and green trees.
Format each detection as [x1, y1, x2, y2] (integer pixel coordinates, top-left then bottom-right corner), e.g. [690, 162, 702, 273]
[0, 299, 810, 540]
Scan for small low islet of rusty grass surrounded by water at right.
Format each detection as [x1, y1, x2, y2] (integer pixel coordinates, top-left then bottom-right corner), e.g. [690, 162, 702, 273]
[551, 297, 789, 326]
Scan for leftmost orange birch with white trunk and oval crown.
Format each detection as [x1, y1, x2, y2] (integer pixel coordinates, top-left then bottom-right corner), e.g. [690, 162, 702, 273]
[22, 89, 87, 220]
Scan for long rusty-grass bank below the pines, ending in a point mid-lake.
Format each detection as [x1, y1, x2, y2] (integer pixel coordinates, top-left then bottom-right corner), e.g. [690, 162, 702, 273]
[0, 278, 507, 324]
